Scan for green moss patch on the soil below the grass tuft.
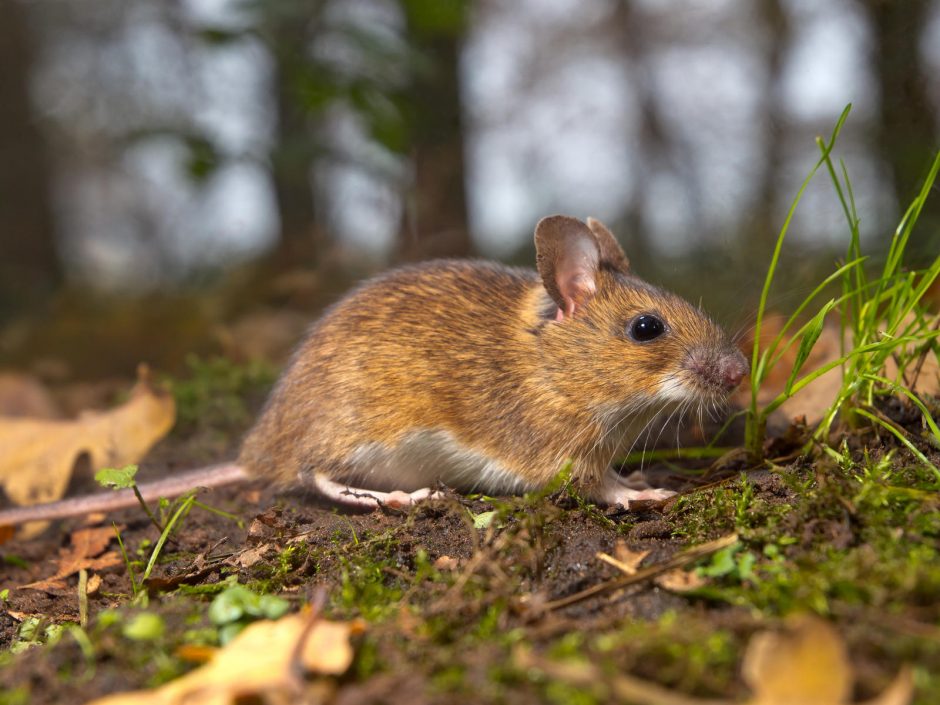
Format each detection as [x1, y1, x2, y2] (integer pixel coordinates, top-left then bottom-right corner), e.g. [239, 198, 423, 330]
[674, 457, 940, 632]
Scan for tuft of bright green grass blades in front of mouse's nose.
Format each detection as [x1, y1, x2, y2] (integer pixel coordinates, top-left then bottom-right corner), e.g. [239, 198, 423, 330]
[745, 106, 940, 468]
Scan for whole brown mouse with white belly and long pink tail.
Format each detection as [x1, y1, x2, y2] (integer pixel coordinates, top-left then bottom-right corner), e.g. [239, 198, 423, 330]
[0, 215, 749, 525]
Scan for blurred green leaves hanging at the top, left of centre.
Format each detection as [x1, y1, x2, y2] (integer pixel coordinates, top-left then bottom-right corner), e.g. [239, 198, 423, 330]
[187, 0, 471, 176]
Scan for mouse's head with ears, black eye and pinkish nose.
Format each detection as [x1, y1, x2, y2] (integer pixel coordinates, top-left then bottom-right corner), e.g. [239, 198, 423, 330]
[535, 215, 748, 417]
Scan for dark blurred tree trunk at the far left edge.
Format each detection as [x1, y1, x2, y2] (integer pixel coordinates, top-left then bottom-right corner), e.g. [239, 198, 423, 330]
[0, 0, 62, 318]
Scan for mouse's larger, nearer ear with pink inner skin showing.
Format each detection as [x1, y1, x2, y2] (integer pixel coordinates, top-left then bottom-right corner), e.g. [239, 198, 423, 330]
[535, 215, 601, 319]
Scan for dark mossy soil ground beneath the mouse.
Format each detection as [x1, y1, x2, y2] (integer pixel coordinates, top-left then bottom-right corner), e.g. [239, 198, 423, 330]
[0, 382, 940, 705]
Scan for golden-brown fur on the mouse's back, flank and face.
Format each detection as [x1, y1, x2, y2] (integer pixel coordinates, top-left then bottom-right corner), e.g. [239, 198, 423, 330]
[240, 217, 730, 498]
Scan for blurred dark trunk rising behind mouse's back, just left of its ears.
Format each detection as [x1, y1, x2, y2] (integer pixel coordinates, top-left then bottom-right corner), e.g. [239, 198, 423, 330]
[399, 0, 472, 260]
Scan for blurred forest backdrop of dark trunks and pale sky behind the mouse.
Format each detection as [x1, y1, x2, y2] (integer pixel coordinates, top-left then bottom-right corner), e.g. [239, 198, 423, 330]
[0, 0, 940, 377]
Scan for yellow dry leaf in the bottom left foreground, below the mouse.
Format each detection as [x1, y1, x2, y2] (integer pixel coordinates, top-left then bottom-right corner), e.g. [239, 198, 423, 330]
[89, 614, 357, 705]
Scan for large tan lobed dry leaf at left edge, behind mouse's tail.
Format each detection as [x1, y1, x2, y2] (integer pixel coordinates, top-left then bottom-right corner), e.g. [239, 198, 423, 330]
[0, 366, 176, 516]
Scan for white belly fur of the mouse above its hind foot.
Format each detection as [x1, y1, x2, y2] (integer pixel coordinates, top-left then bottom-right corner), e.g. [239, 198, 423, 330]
[346, 429, 532, 494]
